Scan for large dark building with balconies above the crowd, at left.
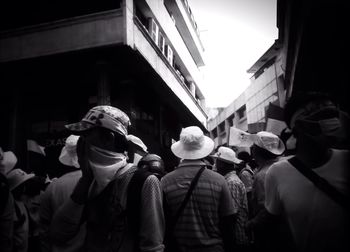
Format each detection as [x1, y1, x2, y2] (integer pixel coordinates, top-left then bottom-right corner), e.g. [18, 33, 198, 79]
[0, 0, 207, 173]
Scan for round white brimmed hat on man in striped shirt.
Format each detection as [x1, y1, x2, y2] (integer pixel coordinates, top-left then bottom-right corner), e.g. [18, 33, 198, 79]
[171, 126, 214, 160]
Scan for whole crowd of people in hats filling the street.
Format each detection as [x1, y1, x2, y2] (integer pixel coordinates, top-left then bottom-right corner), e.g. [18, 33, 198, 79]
[0, 93, 349, 252]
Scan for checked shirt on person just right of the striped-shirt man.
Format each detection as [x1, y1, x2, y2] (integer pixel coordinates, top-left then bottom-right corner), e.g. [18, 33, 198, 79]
[225, 171, 248, 245]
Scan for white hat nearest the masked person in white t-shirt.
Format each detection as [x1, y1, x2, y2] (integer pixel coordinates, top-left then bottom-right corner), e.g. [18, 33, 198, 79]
[254, 131, 285, 155]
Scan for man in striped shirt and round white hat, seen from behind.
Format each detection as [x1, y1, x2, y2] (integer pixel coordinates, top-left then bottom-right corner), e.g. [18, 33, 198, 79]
[161, 126, 234, 252]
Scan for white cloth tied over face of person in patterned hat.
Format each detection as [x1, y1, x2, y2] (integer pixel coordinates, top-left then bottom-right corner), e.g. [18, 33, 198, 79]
[88, 145, 127, 188]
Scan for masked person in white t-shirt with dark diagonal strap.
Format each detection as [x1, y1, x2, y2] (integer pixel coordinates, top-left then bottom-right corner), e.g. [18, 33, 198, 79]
[265, 92, 350, 251]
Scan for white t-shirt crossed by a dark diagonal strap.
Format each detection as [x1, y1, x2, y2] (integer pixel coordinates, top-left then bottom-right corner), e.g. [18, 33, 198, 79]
[265, 149, 350, 252]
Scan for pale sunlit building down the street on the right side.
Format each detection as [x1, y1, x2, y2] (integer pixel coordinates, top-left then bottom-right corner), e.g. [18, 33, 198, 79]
[208, 41, 286, 146]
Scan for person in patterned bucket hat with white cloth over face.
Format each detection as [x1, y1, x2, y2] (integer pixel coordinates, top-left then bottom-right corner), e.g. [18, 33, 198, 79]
[51, 106, 164, 251]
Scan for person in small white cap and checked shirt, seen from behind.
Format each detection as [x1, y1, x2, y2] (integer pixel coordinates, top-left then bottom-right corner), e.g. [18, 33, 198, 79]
[215, 146, 249, 251]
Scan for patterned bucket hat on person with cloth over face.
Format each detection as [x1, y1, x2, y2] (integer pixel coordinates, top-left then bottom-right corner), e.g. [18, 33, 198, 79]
[65, 105, 130, 136]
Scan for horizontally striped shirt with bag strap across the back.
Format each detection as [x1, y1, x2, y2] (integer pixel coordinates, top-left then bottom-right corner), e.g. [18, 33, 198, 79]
[161, 160, 234, 252]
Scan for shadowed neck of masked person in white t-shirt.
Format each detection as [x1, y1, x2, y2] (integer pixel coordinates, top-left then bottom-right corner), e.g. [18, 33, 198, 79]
[295, 145, 332, 169]
